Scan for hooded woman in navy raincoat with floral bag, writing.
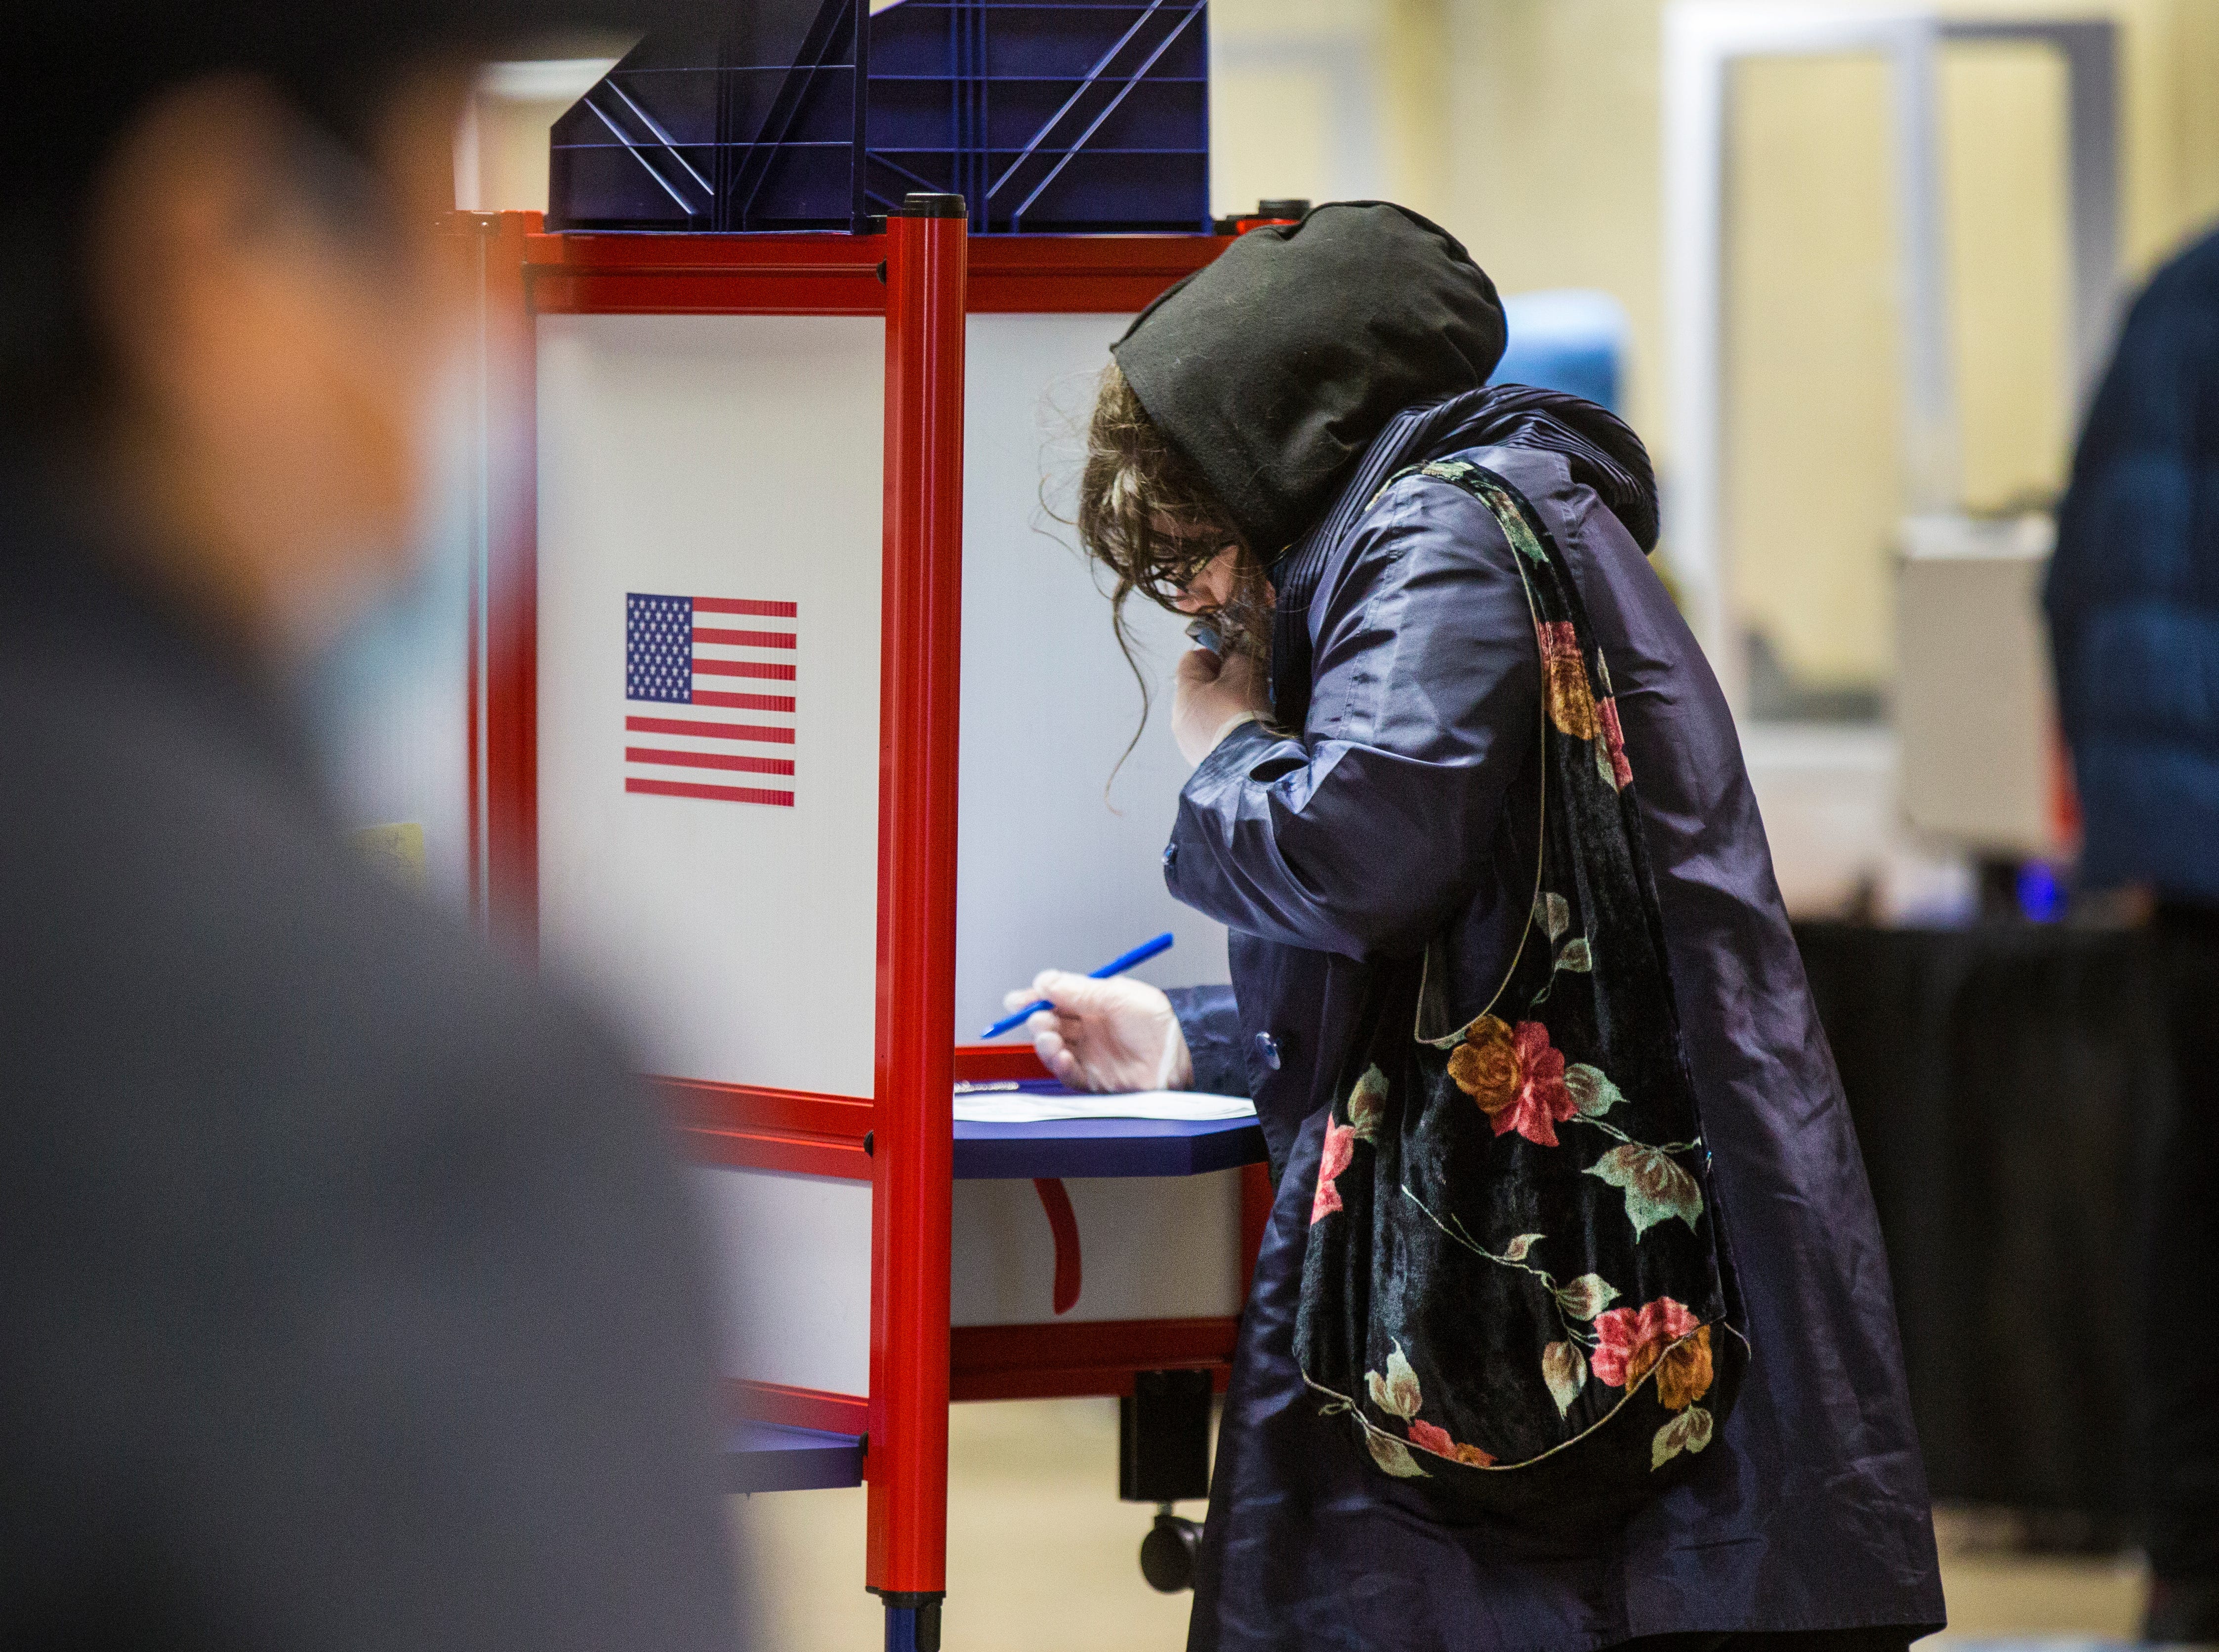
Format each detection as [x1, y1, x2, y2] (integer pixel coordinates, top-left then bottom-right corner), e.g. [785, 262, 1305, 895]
[1023, 204, 1944, 1652]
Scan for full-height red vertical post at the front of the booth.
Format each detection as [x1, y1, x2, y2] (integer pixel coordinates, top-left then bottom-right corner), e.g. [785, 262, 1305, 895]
[865, 195, 970, 1650]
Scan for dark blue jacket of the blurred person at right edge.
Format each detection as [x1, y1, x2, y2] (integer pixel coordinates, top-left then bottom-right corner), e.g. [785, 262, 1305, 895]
[2046, 223, 2219, 905]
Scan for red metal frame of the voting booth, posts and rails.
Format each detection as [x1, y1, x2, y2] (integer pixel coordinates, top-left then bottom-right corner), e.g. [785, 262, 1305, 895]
[459, 213, 1269, 1594]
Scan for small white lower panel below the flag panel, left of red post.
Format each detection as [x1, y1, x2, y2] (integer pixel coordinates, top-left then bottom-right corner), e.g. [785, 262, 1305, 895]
[693, 1168, 869, 1395]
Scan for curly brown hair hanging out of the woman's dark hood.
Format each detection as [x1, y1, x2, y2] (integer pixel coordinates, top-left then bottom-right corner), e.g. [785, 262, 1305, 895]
[1074, 362, 1272, 669]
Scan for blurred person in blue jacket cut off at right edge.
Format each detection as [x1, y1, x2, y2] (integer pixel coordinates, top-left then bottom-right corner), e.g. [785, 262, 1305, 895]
[2046, 223, 2219, 1643]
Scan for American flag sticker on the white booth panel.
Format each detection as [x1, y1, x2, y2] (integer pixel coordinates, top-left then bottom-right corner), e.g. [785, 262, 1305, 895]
[623, 592, 799, 809]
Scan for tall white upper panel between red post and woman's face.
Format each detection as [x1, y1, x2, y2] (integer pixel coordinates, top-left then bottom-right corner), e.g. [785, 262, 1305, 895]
[954, 315, 1225, 1042]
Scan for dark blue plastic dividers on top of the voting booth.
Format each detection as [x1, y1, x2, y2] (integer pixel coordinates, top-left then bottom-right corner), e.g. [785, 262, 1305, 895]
[548, 0, 1209, 235]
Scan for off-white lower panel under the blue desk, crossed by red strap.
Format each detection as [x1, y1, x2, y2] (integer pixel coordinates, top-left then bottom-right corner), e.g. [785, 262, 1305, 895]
[947, 1171, 1240, 1326]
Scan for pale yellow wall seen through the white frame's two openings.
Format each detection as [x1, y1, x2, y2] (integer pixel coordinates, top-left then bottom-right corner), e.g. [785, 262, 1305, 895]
[1724, 44, 2073, 685]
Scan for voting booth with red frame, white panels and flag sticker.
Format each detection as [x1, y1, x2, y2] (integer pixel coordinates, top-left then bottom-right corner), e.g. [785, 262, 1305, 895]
[439, 195, 1269, 1612]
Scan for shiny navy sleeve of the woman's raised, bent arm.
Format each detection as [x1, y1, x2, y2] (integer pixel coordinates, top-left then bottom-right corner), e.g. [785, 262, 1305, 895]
[1165, 477, 1540, 958]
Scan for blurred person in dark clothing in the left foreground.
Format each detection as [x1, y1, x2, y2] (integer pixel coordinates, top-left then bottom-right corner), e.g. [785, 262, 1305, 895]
[0, 0, 737, 1652]
